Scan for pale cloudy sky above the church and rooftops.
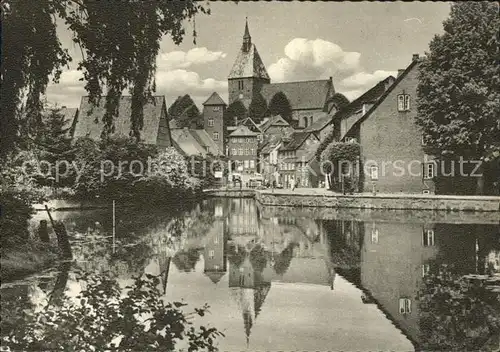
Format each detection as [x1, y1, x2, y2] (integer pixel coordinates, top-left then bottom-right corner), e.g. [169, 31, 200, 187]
[47, 1, 450, 108]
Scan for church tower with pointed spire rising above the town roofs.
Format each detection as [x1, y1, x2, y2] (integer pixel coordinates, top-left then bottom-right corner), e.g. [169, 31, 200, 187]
[227, 21, 271, 108]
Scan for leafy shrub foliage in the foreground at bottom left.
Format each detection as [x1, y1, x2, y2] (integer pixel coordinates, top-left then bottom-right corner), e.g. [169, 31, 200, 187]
[2, 274, 224, 352]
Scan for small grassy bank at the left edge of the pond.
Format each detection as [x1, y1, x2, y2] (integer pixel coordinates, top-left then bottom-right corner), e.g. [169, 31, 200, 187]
[0, 241, 58, 283]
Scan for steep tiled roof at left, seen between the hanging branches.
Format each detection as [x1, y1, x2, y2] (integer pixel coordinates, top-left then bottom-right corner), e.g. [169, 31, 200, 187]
[74, 96, 166, 144]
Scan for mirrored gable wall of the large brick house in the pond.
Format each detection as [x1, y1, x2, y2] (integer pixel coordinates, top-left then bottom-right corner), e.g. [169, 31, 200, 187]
[361, 222, 437, 343]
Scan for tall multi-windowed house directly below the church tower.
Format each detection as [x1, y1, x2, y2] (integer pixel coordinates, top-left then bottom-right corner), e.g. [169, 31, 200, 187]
[228, 125, 258, 174]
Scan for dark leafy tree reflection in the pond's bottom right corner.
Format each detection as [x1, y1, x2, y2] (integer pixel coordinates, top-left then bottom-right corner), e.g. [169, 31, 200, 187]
[419, 265, 500, 351]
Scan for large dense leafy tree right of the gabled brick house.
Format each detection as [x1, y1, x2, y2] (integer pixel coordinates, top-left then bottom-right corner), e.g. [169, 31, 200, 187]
[416, 2, 500, 177]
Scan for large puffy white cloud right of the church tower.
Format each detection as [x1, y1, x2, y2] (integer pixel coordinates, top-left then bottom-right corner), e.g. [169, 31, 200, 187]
[268, 38, 397, 101]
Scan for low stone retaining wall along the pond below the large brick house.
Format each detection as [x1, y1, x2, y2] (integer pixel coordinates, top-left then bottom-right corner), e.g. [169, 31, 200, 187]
[255, 191, 500, 212]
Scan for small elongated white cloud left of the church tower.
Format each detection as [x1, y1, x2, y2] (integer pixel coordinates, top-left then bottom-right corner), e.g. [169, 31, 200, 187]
[157, 47, 226, 70]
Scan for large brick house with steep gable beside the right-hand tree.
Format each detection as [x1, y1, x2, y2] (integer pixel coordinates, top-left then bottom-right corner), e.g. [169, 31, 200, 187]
[341, 54, 437, 194]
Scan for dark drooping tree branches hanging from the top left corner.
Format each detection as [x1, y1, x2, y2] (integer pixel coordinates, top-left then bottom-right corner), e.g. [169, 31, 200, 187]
[0, 0, 209, 156]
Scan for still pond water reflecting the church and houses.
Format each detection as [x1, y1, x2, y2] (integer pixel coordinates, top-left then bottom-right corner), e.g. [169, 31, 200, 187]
[0, 199, 500, 351]
